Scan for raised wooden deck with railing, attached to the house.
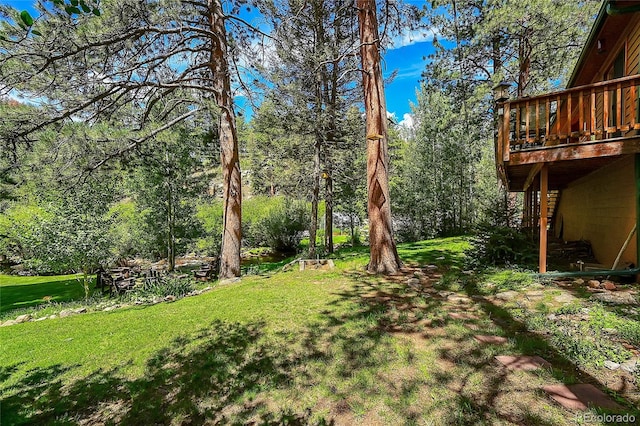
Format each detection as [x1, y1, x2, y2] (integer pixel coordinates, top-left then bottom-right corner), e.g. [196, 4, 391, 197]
[496, 75, 640, 191]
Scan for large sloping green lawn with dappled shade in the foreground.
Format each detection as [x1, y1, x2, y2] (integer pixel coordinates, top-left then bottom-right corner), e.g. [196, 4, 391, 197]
[0, 238, 636, 425]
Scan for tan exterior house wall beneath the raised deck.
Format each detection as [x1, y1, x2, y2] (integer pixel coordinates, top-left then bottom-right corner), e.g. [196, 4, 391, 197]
[554, 156, 637, 267]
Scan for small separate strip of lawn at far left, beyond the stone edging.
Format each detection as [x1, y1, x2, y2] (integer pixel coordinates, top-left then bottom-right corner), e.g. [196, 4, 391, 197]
[0, 275, 88, 314]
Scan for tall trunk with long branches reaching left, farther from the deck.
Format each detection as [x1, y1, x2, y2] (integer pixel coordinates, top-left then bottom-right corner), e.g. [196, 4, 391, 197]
[209, 0, 242, 278]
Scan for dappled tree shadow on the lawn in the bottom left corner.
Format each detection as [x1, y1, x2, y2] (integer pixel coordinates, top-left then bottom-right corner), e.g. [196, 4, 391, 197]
[1, 321, 336, 425]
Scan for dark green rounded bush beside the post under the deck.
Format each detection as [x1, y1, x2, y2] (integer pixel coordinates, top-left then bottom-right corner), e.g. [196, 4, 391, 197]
[465, 226, 537, 268]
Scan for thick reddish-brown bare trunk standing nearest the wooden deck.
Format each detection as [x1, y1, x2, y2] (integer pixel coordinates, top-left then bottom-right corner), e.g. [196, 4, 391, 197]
[357, 0, 402, 274]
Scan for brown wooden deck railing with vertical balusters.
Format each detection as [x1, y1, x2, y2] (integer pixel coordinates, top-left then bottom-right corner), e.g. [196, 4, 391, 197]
[497, 75, 640, 161]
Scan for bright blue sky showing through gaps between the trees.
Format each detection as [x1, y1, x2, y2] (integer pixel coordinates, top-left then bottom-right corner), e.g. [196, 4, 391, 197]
[0, 0, 434, 121]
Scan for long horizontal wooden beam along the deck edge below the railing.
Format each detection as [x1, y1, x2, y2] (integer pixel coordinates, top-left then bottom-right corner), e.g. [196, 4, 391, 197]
[508, 137, 640, 166]
